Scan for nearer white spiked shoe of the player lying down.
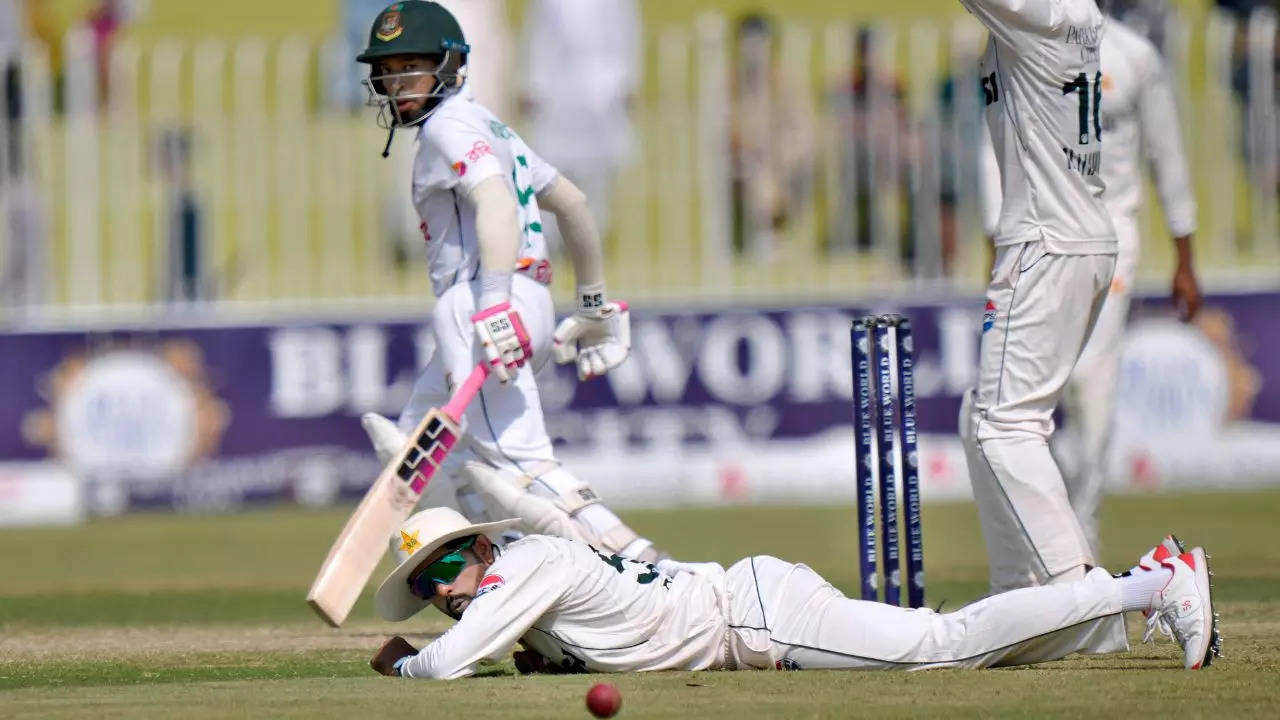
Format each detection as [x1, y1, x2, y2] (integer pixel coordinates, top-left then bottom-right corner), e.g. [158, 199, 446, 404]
[1147, 547, 1221, 670]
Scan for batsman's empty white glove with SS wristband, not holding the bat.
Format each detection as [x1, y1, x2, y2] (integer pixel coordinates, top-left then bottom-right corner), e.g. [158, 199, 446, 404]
[552, 288, 631, 380]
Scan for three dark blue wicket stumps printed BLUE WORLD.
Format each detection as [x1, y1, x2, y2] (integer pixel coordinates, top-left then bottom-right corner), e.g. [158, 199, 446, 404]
[850, 315, 924, 607]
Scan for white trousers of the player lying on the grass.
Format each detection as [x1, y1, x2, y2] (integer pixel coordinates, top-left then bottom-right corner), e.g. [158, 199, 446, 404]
[726, 556, 1128, 670]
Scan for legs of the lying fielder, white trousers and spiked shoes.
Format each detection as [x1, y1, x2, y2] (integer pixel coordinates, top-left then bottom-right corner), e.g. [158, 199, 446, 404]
[747, 550, 1216, 670]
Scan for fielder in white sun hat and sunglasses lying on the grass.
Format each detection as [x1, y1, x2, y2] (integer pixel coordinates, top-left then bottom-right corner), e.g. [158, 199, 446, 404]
[371, 507, 1217, 679]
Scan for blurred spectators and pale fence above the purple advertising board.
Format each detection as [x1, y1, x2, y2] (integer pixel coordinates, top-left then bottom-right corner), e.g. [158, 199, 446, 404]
[0, 0, 1280, 316]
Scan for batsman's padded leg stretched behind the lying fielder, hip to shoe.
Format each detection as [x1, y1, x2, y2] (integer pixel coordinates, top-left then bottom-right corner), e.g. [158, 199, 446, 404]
[433, 275, 658, 560]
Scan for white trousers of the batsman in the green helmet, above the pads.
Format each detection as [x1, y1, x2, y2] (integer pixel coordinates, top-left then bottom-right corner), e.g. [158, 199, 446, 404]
[399, 274, 556, 519]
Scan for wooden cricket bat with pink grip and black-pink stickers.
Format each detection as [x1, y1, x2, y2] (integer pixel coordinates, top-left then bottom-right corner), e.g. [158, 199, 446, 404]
[307, 363, 489, 628]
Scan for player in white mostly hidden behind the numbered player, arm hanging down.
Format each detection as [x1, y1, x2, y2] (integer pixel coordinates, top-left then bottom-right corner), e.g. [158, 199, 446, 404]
[984, 15, 1201, 556]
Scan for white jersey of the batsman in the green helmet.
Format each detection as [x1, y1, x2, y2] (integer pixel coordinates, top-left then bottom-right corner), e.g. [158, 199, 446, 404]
[413, 87, 557, 297]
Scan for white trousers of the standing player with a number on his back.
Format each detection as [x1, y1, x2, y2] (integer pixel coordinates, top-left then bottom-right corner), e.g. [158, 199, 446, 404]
[960, 242, 1116, 592]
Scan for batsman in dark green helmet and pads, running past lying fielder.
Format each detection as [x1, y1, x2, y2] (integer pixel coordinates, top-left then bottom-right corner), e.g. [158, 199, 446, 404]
[357, 0, 658, 560]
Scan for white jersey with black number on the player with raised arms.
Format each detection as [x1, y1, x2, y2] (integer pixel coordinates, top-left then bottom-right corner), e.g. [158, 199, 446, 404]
[960, 0, 1116, 255]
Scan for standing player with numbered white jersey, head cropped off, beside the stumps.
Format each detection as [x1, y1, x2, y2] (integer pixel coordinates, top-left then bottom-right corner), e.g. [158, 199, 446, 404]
[960, 0, 1125, 594]
